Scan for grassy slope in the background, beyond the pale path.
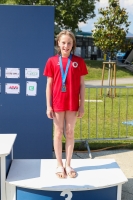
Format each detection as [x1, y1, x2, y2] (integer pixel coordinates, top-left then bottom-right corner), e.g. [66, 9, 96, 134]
[85, 60, 133, 81]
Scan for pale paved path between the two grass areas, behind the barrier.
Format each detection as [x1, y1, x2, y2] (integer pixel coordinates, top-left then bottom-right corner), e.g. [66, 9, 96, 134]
[85, 77, 133, 86]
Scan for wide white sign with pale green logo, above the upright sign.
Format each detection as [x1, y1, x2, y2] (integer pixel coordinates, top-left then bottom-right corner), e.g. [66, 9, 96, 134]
[25, 68, 39, 78]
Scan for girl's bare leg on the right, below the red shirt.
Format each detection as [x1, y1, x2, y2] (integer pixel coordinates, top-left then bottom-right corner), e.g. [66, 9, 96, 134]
[65, 111, 77, 177]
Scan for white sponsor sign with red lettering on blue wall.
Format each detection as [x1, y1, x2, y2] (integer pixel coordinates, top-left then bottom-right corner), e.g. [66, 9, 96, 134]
[5, 83, 20, 94]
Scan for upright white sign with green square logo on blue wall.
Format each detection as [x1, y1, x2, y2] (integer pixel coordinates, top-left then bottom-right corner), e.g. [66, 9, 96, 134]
[26, 81, 37, 96]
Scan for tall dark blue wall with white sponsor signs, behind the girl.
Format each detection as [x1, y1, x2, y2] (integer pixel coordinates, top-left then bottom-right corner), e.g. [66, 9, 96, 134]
[0, 5, 54, 159]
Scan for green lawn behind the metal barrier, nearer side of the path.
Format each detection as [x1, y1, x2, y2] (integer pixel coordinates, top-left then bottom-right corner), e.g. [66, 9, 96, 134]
[72, 89, 133, 149]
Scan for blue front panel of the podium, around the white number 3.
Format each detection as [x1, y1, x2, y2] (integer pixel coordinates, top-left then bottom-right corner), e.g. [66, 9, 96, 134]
[16, 187, 117, 200]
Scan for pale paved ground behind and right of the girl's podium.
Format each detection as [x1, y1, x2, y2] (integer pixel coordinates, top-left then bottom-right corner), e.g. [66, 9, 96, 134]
[54, 149, 133, 200]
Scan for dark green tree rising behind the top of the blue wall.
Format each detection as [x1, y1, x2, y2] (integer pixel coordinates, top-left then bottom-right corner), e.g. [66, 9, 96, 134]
[8, 0, 99, 31]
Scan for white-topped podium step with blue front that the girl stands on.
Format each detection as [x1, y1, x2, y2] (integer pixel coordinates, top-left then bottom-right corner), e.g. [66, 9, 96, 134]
[6, 159, 127, 200]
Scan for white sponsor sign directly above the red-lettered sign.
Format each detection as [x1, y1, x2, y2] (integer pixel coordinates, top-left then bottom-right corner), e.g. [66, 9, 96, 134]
[5, 68, 20, 78]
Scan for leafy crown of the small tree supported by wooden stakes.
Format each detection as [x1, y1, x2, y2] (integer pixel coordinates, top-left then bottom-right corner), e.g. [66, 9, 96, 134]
[92, 0, 131, 58]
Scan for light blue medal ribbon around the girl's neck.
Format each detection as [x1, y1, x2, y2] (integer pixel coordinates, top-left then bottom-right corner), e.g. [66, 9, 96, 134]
[59, 54, 72, 85]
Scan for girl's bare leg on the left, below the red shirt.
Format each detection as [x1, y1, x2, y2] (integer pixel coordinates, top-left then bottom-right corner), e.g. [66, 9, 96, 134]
[53, 112, 66, 178]
